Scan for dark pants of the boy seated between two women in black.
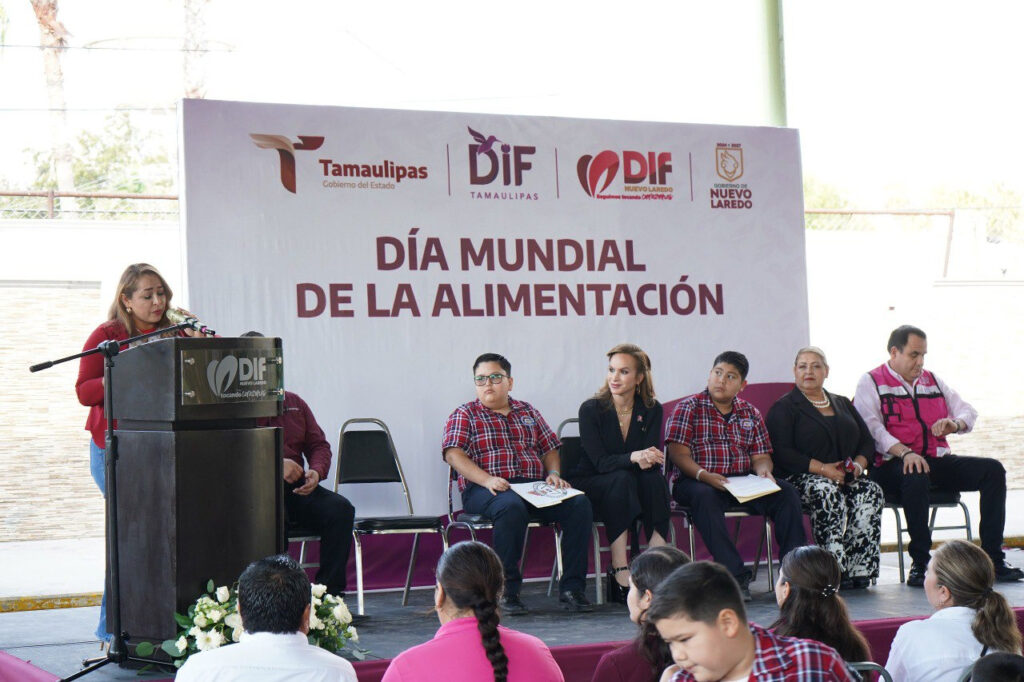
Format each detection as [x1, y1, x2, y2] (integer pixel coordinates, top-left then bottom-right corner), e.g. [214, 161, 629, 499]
[672, 477, 807, 577]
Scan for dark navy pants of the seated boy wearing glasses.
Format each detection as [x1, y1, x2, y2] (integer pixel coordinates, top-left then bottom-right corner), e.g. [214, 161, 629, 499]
[462, 478, 593, 595]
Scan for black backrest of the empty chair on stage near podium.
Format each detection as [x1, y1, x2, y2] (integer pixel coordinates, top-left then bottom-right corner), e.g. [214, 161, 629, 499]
[334, 418, 414, 514]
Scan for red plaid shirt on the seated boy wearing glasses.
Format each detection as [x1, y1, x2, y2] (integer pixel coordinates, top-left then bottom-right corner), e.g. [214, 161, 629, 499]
[441, 397, 561, 491]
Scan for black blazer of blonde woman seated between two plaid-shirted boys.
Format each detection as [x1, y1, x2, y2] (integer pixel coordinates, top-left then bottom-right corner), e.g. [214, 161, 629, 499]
[574, 396, 662, 476]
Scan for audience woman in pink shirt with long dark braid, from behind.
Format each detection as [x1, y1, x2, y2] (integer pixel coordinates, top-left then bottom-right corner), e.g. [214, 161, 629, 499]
[382, 542, 564, 682]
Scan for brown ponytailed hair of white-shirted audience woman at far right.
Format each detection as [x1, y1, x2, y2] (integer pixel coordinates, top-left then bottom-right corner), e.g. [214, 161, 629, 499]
[930, 540, 1021, 653]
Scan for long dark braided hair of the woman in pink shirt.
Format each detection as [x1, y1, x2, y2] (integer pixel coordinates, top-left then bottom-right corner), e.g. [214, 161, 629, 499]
[437, 542, 509, 682]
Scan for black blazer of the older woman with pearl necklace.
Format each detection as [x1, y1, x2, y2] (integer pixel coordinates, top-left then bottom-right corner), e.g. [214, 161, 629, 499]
[765, 388, 874, 476]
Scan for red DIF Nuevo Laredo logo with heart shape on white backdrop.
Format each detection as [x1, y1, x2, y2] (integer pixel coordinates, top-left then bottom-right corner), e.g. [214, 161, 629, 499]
[577, 150, 674, 201]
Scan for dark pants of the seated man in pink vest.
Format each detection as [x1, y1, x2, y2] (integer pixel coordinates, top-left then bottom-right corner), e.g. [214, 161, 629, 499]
[871, 455, 1007, 566]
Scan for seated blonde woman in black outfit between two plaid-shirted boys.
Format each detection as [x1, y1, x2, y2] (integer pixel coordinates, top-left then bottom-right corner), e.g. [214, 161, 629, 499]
[569, 343, 670, 604]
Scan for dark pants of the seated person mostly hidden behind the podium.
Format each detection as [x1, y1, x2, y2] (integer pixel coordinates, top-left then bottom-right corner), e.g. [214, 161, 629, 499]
[285, 483, 355, 596]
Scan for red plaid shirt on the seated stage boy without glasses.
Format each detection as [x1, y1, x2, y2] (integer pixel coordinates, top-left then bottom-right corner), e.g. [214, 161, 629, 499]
[665, 389, 772, 476]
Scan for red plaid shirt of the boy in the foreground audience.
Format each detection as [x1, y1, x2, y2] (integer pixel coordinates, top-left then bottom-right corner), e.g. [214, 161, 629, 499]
[672, 623, 857, 682]
